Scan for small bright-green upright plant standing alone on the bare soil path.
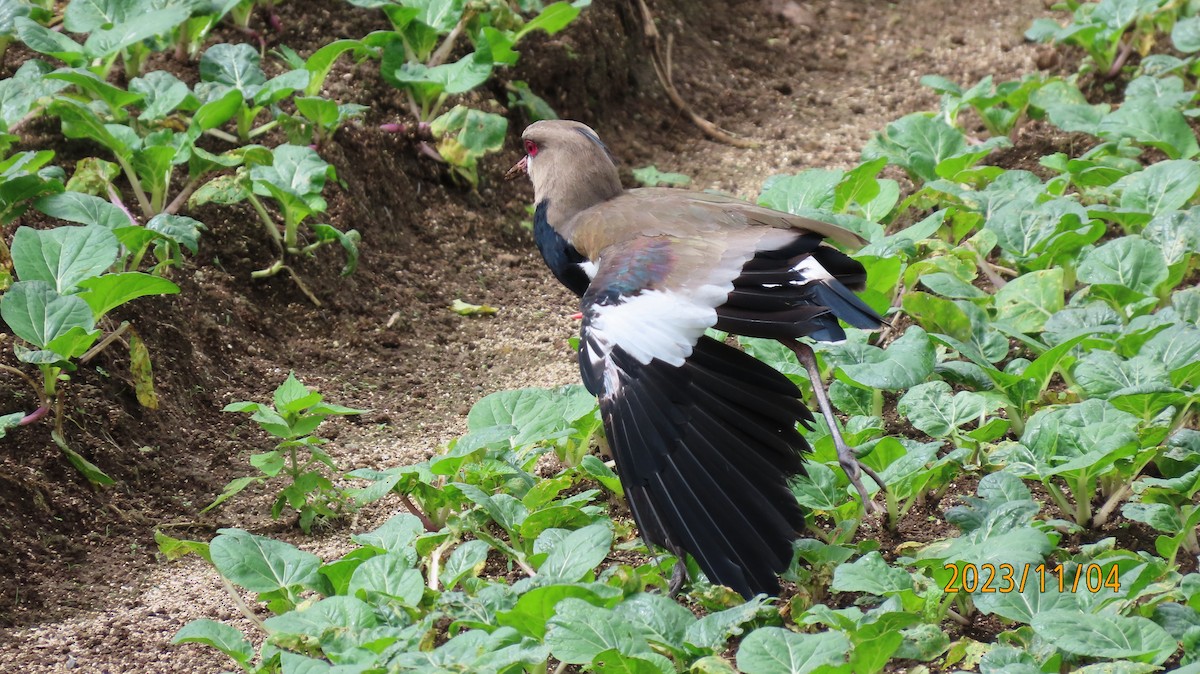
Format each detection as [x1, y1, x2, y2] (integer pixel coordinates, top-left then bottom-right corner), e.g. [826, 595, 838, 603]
[204, 373, 364, 534]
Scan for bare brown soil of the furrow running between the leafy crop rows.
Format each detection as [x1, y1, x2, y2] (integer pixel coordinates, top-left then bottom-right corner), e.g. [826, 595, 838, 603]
[0, 0, 1055, 674]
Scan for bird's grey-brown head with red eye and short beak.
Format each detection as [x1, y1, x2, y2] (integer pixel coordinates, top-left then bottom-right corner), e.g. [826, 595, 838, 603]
[506, 120, 622, 212]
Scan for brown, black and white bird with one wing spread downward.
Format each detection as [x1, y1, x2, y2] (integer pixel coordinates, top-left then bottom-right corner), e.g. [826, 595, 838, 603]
[506, 120, 884, 600]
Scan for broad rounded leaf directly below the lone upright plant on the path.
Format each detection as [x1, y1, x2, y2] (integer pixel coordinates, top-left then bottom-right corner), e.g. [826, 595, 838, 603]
[209, 529, 320, 590]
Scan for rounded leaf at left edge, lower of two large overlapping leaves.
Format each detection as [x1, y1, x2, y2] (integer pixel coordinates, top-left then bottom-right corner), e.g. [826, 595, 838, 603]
[0, 281, 96, 347]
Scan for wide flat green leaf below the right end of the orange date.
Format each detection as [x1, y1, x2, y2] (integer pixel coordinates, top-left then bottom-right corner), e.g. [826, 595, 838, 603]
[1032, 609, 1178, 664]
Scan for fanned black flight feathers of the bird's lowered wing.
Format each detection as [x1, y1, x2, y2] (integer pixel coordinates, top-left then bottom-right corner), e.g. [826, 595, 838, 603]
[600, 337, 812, 597]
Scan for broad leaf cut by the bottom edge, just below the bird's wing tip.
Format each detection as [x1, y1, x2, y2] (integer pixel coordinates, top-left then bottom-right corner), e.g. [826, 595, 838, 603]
[738, 627, 851, 674]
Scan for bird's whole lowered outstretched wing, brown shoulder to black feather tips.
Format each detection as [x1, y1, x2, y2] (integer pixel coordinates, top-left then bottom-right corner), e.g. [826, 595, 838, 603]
[578, 236, 829, 597]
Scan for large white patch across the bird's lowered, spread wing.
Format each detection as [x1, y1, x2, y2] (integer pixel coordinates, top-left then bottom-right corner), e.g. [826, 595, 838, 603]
[588, 285, 728, 367]
